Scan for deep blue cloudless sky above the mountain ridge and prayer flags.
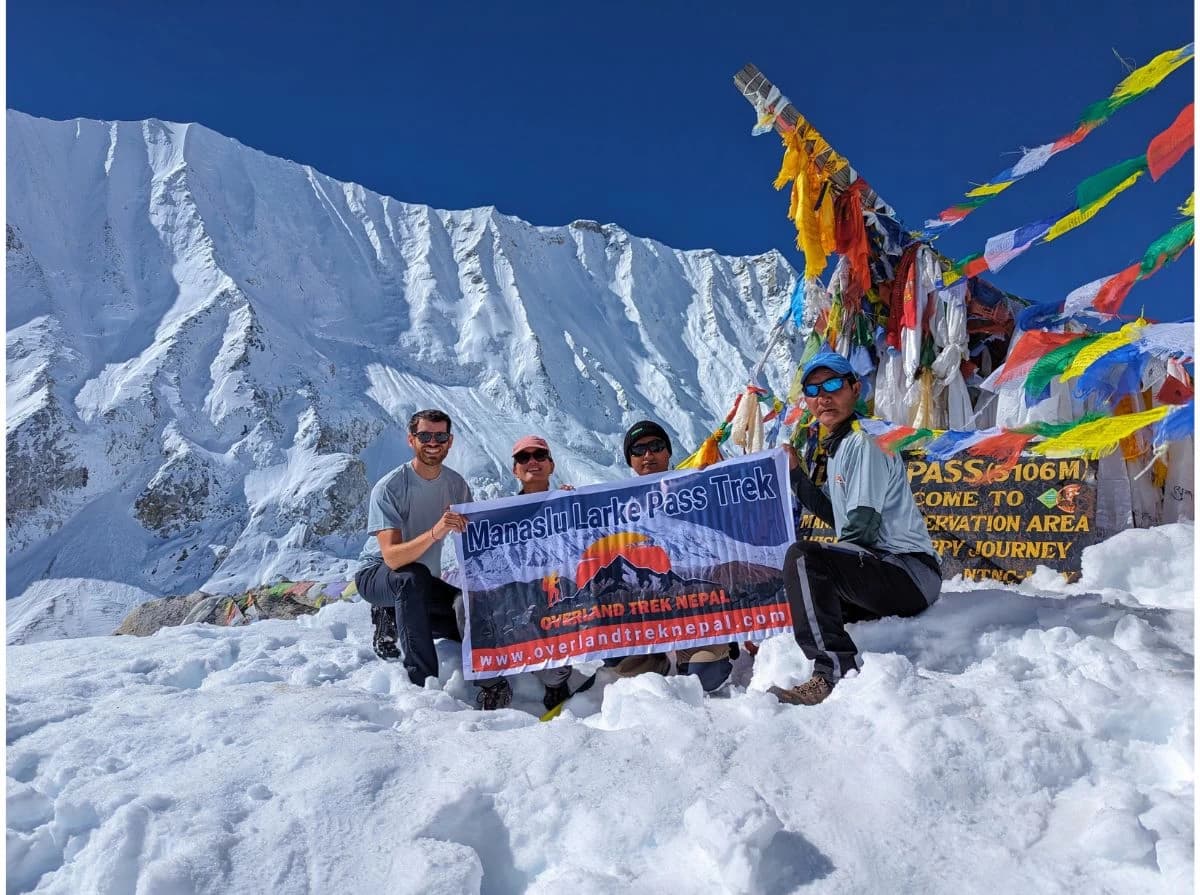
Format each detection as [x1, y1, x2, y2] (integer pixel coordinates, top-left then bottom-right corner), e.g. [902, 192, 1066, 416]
[7, 0, 1194, 319]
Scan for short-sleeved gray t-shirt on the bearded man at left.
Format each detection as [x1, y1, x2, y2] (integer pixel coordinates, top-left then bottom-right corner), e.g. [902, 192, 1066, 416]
[359, 462, 470, 576]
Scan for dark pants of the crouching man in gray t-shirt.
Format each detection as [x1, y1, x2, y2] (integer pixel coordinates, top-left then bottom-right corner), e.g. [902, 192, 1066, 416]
[354, 563, 462, 686]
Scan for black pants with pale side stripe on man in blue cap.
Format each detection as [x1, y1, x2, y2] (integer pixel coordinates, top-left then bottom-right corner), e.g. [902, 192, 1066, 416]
[784, 541, 929, 680]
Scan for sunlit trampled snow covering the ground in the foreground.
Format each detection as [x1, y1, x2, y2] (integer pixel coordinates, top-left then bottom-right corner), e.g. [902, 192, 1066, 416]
[7, 524, 1194, 895]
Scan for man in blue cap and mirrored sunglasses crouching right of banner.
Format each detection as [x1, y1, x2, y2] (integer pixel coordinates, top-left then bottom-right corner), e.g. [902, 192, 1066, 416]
[770, 350, 942, 705]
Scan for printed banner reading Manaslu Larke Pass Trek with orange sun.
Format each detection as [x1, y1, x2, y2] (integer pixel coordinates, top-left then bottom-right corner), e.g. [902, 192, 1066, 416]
[451, 450, 794, 679]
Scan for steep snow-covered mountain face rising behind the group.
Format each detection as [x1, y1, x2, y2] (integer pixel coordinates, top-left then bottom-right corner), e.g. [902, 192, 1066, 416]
[6, 112, 796, 595]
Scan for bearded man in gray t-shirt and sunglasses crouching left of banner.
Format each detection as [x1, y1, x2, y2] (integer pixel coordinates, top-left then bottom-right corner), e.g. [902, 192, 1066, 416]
[354, 410, 512, 709]
